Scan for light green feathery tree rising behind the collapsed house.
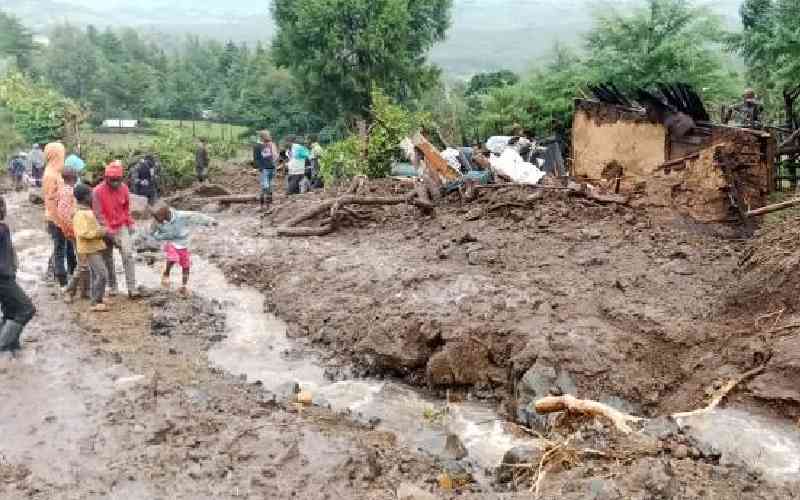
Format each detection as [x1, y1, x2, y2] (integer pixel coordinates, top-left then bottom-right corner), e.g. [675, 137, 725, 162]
[586, 0, 740, 100]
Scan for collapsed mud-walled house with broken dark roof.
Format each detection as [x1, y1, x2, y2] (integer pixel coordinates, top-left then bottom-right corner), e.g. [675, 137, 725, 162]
[572, 84, 777, 222]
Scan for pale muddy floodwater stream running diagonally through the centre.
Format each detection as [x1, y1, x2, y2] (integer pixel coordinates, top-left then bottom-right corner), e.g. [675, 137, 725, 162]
[130, 252, 535, 478]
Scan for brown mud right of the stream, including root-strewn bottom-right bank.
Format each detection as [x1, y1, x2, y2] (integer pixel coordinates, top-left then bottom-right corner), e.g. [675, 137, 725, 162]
[189, 177, 796, 499]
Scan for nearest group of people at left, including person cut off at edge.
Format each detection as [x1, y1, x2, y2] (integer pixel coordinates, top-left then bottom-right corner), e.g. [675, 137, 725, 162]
[0, 142, 216, 352]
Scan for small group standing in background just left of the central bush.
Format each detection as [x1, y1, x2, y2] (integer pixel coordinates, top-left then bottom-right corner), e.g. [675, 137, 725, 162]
[253, 130, 322, 207]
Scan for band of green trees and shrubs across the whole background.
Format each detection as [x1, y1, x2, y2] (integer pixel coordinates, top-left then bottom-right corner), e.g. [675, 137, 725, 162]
[0, 0, 800, 188]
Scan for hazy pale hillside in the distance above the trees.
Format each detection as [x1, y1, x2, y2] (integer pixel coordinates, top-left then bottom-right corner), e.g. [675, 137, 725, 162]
[0, 0, 741, 76]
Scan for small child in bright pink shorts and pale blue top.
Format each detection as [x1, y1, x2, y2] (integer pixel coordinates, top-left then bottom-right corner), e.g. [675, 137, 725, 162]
[150, 203, 217, 295]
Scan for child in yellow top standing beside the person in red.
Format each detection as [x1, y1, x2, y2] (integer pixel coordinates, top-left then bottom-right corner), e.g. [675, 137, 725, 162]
[67, 184, 108, 312]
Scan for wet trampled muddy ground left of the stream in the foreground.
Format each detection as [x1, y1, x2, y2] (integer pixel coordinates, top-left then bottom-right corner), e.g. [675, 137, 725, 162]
[0, 194, 450, 499]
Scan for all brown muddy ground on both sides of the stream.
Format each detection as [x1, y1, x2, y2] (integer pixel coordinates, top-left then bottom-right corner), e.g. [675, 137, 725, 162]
[0, 163, 800, 499]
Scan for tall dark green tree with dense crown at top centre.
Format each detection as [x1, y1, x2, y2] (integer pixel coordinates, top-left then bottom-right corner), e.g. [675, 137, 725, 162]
[272, 0, 452, 119]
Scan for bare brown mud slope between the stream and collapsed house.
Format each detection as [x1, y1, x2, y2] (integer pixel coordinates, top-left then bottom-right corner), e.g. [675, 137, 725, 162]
[191, 180, 751, 423]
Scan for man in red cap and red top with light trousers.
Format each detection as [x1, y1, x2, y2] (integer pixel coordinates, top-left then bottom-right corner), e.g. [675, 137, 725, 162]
[92, 161, 139, 299]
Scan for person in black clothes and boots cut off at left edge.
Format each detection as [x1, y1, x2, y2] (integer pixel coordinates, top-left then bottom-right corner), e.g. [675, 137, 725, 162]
[0, 197, 36, 352]
